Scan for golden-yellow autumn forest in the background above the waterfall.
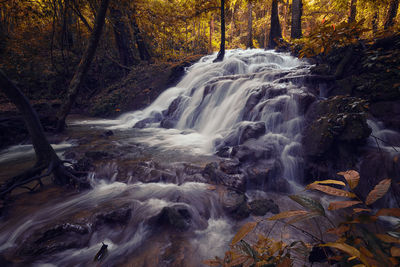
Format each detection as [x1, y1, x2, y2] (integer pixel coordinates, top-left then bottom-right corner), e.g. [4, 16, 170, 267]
[0, 0, 399, 102]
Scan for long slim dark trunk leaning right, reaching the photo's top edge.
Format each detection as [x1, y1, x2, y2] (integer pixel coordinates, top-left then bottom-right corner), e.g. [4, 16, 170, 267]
[56, 0, 109, 132]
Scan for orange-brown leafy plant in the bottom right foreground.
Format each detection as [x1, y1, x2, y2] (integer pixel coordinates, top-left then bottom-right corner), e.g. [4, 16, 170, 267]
[203, 170, 400, 267]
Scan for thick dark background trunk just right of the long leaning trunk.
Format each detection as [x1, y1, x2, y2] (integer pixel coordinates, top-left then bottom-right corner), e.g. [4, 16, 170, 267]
[110, 8, 135, 67]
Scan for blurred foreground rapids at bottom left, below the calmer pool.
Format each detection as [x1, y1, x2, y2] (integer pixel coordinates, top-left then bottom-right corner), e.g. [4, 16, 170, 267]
[0, 181, 233, 266]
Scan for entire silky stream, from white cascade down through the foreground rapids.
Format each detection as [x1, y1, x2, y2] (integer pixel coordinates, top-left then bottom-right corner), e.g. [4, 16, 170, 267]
[0, 50, 322, 266]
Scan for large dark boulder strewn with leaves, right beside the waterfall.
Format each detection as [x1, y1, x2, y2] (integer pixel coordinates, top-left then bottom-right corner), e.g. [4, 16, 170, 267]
[302, 96, 372, 182]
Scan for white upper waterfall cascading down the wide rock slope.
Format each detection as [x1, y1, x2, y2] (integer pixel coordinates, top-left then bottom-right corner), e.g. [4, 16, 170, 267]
[77, 49, 310, 180]
